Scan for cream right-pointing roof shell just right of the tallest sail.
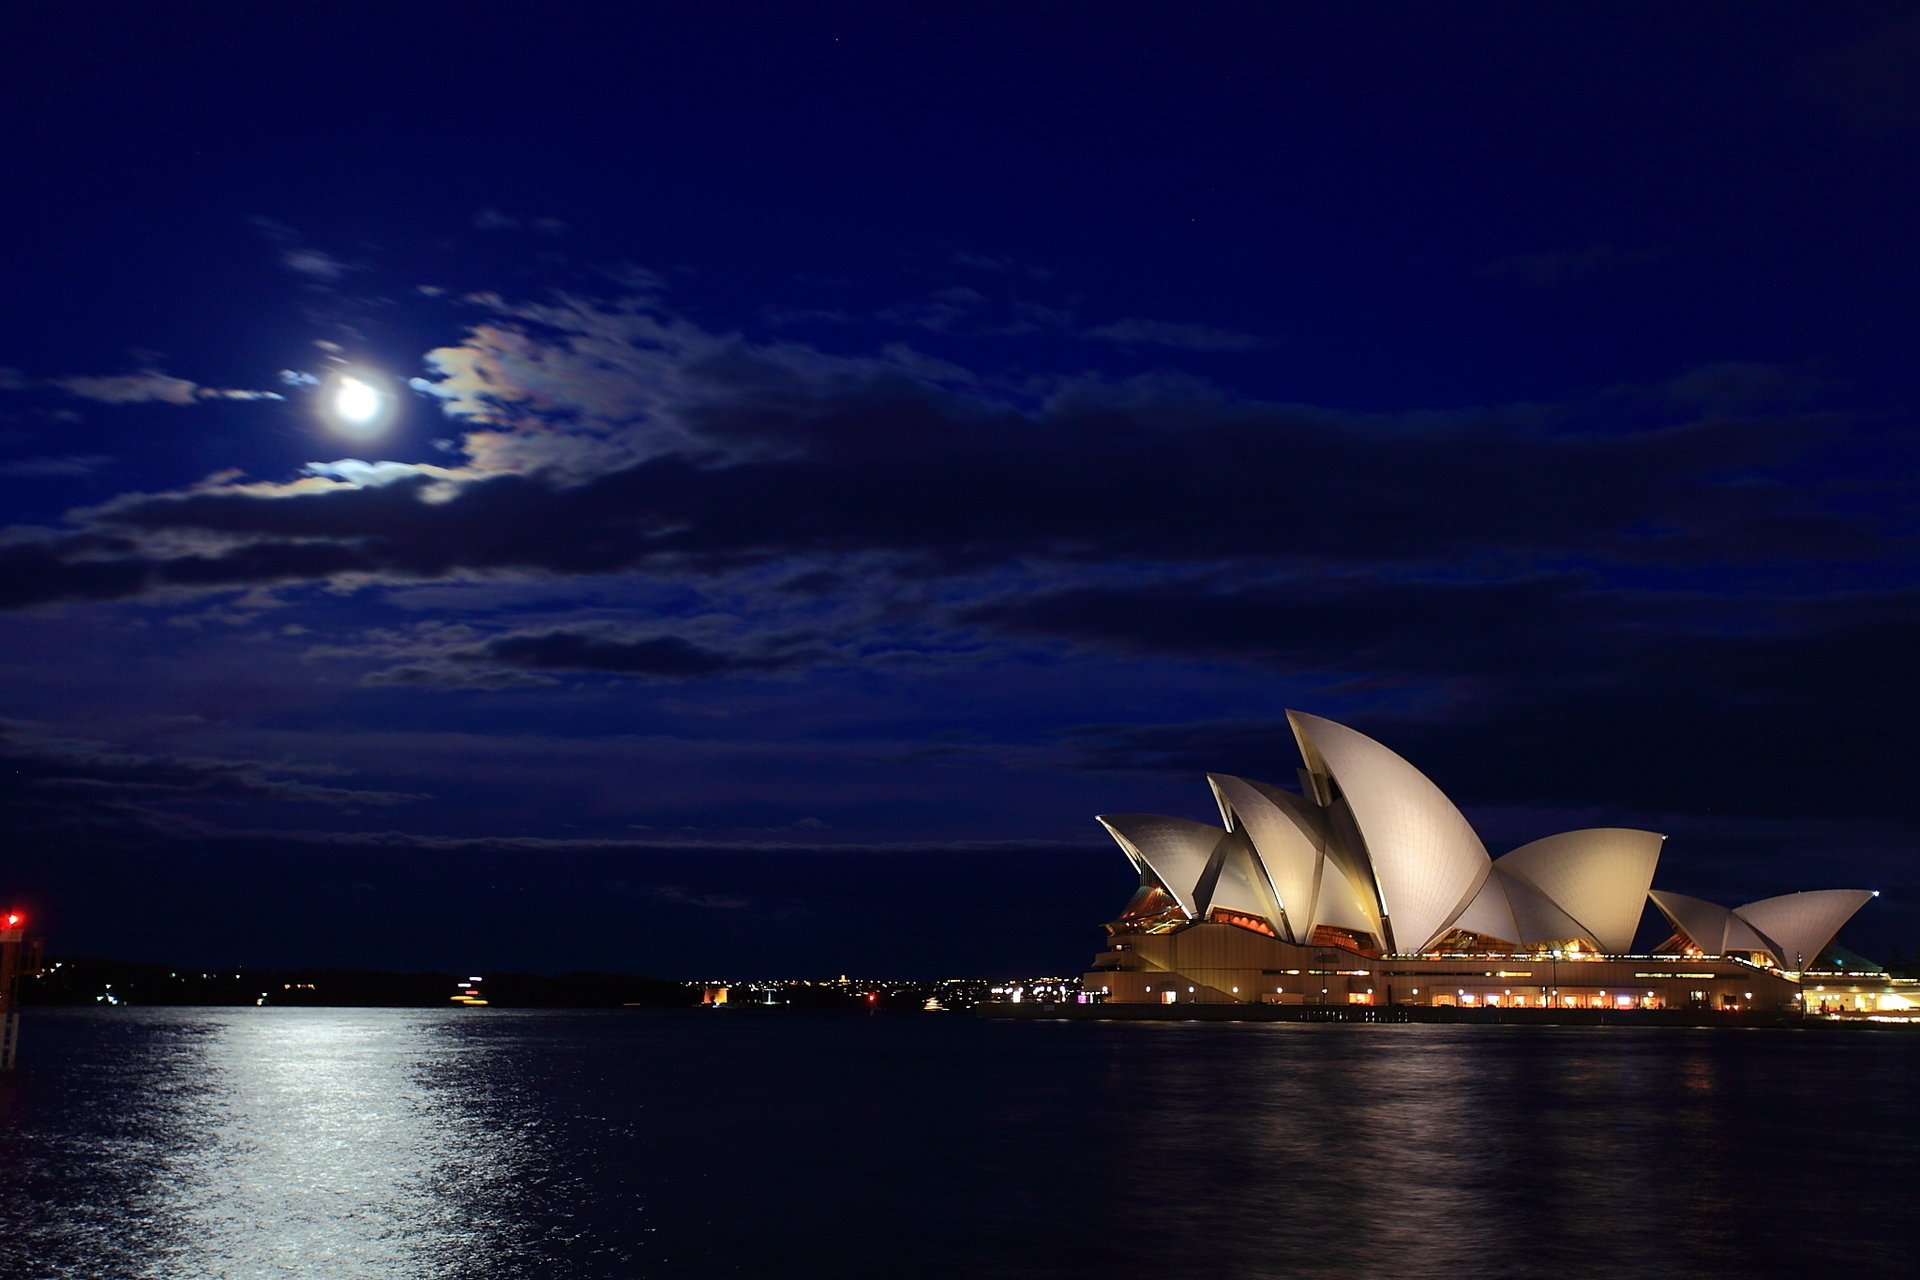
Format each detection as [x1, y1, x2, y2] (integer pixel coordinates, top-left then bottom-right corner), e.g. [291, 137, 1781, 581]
[1494, 827, 1667, 956]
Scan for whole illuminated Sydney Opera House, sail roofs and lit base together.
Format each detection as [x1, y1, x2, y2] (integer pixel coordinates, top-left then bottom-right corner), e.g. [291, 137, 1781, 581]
[1081, 712, 1874, 1009]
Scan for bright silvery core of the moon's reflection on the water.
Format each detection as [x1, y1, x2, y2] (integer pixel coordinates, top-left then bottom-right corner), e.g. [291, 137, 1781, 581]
[152, 1009, 524, 1276]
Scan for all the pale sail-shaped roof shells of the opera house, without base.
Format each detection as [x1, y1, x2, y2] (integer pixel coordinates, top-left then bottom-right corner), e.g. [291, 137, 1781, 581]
[1100, 712, 1872, 969]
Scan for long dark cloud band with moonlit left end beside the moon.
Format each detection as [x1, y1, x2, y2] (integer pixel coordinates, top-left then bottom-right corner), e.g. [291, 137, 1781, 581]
[0, 282, 1910, 621]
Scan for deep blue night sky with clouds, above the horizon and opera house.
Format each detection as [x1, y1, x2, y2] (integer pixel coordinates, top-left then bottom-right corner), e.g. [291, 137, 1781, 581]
[0, 0, 1920, 977]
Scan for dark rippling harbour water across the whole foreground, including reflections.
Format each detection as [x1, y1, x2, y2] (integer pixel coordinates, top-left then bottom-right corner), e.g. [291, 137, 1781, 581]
[0, 1007, 1920, 1280]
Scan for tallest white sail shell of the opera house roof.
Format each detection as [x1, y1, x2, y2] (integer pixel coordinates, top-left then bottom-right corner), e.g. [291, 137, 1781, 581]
[1286, 712, 1492, 952]
